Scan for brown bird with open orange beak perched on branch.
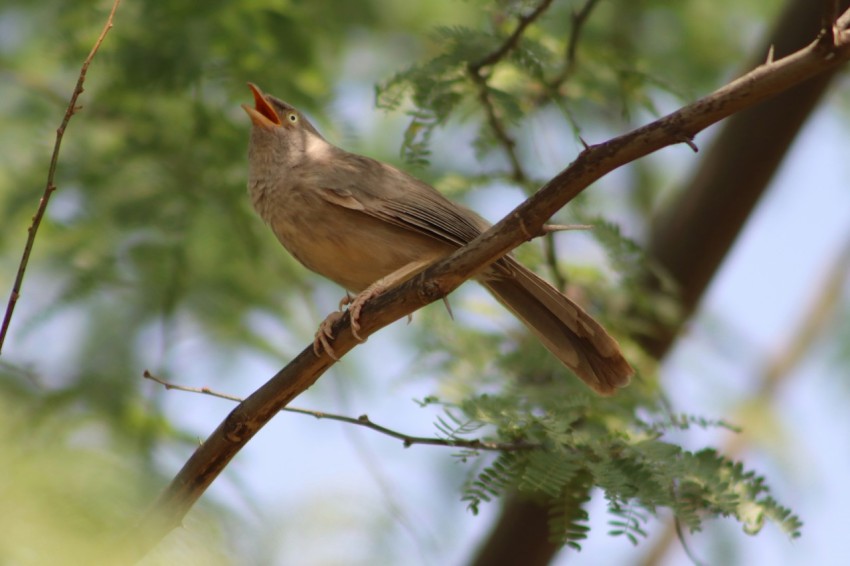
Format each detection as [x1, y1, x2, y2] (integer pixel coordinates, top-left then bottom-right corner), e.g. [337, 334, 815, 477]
[242, 83, 634, 395]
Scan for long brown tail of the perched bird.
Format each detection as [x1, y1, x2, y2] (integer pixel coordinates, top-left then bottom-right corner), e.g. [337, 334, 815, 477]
[480, 257, 634, 395]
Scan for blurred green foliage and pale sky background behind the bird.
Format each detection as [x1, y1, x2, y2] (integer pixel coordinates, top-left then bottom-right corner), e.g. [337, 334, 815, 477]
[0, 0, 850, 565]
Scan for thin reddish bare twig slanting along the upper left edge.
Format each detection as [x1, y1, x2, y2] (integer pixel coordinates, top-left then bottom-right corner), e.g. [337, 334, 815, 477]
[0, 0, 121, 352]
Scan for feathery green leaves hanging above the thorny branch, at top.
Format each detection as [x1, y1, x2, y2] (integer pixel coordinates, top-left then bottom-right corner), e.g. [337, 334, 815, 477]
[376, 0, 742, 169]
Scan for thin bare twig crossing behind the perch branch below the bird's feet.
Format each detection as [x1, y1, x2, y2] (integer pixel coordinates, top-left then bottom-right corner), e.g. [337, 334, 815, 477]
[142, 370, 537, 452]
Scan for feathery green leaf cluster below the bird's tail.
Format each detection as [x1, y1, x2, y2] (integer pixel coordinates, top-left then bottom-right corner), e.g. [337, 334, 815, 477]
[424, 386, 802, 547]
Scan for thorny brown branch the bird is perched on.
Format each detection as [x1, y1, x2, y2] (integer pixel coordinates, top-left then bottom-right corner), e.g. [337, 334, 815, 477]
[122, 7, 850, 556]
